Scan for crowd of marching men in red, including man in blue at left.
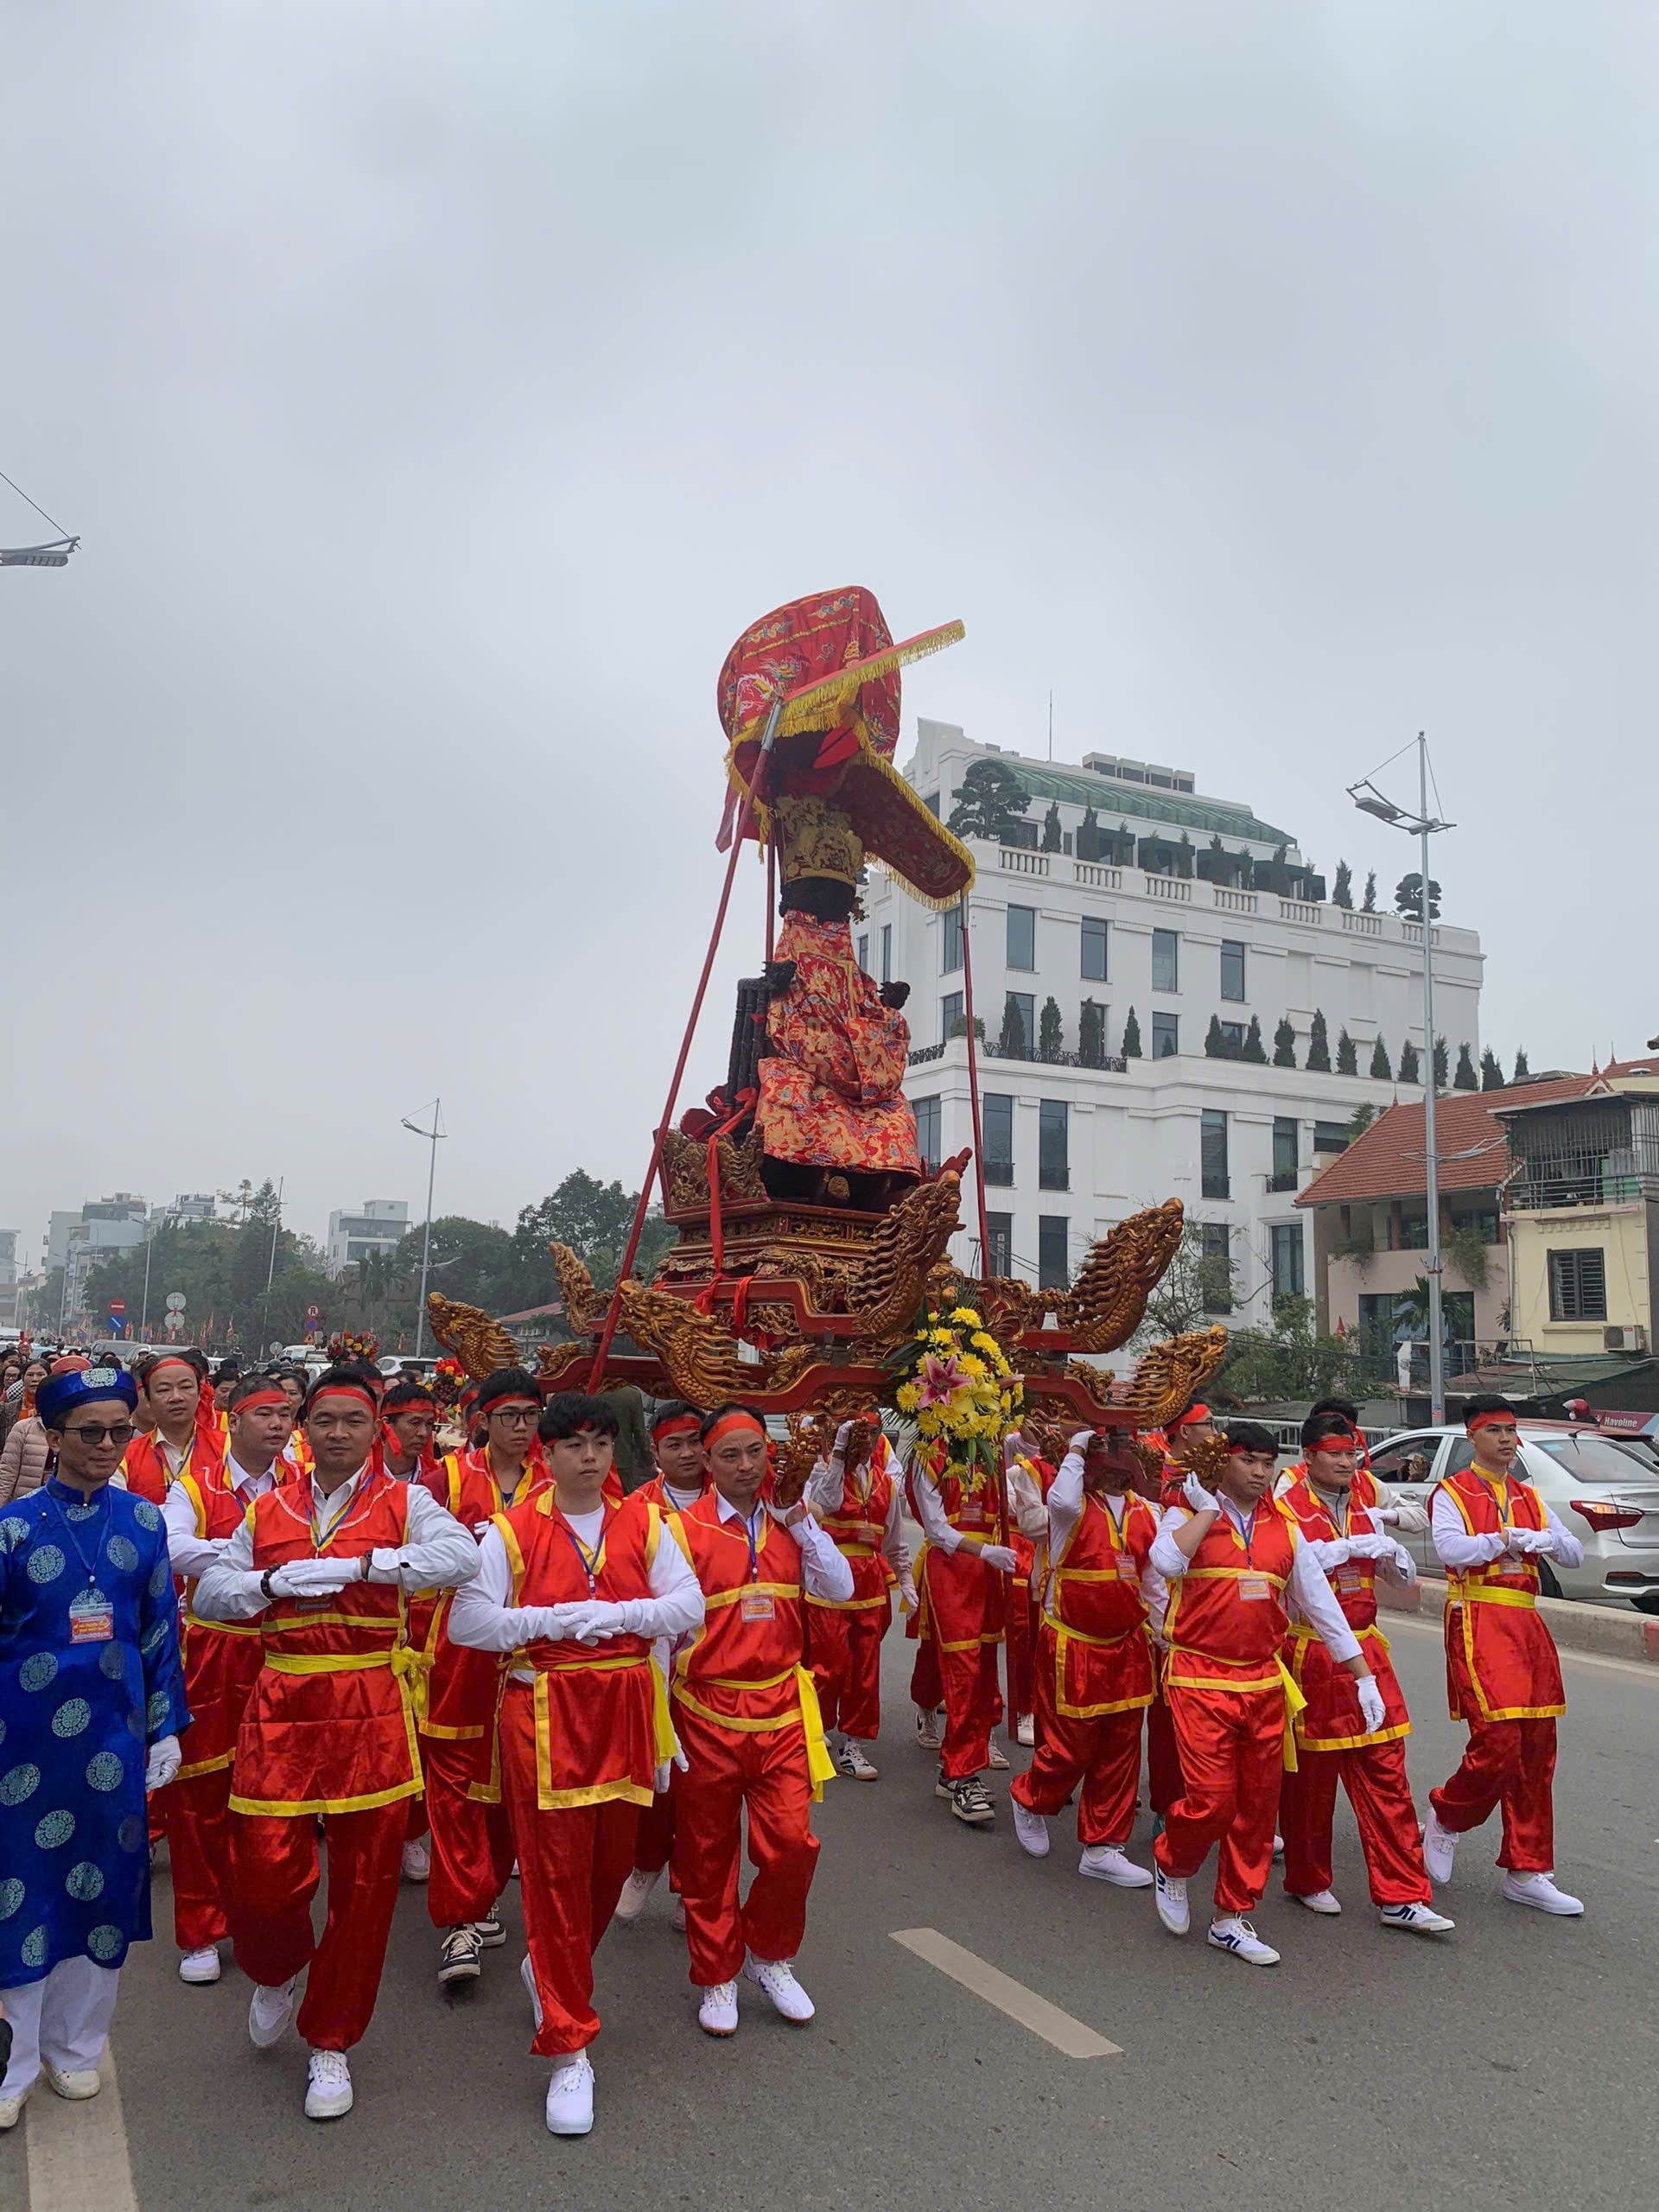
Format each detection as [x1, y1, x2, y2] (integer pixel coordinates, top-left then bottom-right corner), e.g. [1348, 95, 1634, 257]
[0, 1350, 1584, 2134]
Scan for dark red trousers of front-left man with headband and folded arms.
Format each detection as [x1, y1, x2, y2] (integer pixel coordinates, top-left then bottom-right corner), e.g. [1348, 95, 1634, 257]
[230, 1798, 410, 2050]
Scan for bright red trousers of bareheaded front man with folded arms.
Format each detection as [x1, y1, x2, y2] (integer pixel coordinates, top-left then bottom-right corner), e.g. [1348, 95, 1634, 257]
[502, 1683, 639, 2059]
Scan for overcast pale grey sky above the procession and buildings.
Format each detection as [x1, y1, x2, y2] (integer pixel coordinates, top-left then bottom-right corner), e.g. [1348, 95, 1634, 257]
[0, 0, 1659, 1256]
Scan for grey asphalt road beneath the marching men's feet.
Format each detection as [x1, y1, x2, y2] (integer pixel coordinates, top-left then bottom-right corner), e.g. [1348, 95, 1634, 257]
[0, 1619, 1659, 2212]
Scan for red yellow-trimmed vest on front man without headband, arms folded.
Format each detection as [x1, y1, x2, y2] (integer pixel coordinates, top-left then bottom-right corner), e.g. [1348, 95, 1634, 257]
[495, 1484, 664, 1812]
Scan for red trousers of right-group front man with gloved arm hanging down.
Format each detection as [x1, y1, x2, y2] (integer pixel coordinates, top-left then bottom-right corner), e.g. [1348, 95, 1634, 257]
[1154, 1688, 1285, 1913]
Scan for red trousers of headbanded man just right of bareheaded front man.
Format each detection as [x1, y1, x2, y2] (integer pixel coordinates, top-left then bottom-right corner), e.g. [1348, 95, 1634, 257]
[675, 1703, 818, 1988]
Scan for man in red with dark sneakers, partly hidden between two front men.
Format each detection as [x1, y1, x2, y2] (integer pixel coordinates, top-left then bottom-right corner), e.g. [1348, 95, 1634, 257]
[420, 1367, 549, 1988]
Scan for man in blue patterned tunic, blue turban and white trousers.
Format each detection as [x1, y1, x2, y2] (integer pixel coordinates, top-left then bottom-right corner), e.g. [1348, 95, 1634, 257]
[0, 1367, 190, 2128]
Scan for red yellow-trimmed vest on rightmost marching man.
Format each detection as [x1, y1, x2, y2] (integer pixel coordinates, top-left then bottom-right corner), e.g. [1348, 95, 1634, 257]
[1429, 1466, 1566, 1723]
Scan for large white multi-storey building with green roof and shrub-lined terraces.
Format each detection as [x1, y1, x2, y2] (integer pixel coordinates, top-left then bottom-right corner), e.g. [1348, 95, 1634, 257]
[854, 721, 1484, 1320]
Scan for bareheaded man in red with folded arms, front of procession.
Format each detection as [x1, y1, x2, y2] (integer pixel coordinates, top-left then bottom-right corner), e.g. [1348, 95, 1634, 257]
[449, 1391, 703, 2134]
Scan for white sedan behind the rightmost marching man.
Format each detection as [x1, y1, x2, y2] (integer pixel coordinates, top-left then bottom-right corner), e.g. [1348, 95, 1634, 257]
[1371, 1421, 1659, 1612]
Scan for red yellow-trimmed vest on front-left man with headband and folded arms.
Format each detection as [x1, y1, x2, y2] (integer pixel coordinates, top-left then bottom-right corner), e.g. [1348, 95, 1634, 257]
[230, 1473, 420, 1814]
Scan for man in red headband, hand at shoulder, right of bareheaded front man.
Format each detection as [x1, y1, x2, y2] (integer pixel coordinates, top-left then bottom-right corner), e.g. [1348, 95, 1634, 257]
[672, 1405, 852, 2035]
